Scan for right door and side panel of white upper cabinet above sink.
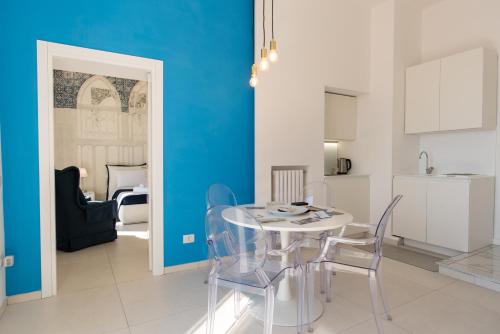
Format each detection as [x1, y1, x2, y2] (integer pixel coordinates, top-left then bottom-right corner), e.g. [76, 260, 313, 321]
[439, 48, 498, 130]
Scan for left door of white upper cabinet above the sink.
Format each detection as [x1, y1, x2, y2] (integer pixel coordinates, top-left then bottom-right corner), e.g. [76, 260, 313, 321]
[405, 60, 441, 134]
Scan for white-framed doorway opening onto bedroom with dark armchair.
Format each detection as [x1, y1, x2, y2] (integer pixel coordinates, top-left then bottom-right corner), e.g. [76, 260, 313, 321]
[37, 41, 164, 298]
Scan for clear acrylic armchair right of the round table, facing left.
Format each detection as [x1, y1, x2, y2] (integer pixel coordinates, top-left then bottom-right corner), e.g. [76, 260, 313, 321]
[305, 195, 403, 333]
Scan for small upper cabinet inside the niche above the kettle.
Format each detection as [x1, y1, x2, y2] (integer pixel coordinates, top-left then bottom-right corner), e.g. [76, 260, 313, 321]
[325, 93, 357, 140]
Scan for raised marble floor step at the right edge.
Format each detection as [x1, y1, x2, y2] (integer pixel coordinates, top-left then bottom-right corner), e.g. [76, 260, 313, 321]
[439, 245, 500, 292]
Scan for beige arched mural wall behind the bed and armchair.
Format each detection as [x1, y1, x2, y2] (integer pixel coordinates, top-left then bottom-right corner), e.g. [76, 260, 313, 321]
[54, 70, 148, 199]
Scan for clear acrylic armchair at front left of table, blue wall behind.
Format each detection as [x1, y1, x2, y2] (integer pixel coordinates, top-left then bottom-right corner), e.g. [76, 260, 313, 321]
[205, 206, 305, 334]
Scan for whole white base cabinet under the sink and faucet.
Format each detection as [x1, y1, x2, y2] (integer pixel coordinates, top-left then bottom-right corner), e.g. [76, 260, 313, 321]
[392, 176, 494, 252]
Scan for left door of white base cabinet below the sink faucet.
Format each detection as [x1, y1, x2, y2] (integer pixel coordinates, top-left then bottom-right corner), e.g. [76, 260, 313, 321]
[392, 177, 427, 242]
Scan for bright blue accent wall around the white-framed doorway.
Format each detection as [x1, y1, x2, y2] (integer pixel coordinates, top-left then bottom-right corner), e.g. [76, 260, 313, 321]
[0, 0, 254, 295]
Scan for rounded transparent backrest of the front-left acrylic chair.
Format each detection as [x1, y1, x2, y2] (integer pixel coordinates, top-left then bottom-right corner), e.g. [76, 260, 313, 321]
[205, 205, 269, 277]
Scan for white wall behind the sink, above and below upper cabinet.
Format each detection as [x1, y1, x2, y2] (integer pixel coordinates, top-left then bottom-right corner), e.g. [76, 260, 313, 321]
[420, 0, 500, 243]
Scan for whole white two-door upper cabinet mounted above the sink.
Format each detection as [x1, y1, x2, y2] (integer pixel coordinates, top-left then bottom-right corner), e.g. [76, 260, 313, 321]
[405, 48, 498, 134]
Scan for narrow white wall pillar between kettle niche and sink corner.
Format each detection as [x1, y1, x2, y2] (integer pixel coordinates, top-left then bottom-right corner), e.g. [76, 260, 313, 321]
[339, 0, 394, 222]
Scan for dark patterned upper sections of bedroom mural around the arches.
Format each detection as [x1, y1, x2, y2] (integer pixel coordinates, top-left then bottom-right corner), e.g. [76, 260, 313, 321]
[54, 70, 139, 112]
